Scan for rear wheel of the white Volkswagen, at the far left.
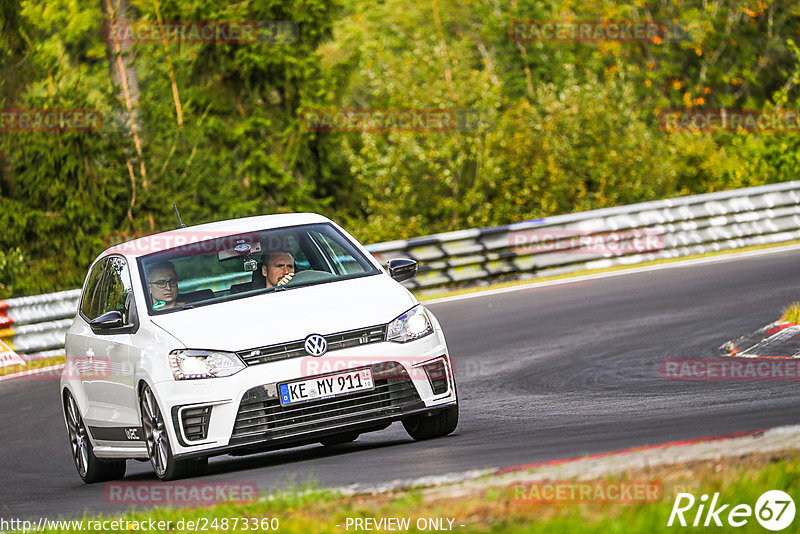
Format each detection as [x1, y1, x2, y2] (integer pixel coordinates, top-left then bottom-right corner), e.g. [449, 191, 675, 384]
[64, 391, 126, 484]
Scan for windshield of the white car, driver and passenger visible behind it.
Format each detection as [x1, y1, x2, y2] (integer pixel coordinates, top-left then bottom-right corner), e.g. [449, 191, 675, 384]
[138, 224, 379, 314]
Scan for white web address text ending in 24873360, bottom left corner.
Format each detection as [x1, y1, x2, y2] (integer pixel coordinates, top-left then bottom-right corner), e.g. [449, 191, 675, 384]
[0, 517, 280, 534]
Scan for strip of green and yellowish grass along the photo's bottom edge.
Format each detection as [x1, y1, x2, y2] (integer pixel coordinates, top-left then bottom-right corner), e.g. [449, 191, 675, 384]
[37, 451, 800, 534]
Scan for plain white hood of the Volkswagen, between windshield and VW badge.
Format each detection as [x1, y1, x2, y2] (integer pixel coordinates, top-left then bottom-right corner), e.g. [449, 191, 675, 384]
[151, 274, 417, 351]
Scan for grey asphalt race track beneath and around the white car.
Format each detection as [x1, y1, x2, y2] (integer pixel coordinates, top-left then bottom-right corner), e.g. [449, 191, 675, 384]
[0, 250, 800, 519]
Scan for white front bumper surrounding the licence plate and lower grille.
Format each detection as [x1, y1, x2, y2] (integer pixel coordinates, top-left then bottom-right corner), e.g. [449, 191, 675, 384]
[154, 330, 457, 458]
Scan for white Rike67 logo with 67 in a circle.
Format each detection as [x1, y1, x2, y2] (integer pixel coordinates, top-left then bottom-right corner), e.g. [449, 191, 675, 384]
[667, 490, 796, 531]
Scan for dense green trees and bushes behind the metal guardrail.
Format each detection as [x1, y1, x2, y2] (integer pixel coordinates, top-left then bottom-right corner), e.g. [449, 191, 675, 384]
[0, 0, 800, 297]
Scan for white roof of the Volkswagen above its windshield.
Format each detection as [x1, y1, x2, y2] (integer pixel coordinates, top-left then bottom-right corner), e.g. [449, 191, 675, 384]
[104, 213, 331, 259]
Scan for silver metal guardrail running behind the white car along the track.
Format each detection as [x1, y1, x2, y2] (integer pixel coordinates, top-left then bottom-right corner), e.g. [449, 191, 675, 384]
[0, 182, 800, 359]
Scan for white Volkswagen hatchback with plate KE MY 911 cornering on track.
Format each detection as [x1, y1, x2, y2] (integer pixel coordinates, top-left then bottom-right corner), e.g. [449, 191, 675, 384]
[61, 213, 458, 483]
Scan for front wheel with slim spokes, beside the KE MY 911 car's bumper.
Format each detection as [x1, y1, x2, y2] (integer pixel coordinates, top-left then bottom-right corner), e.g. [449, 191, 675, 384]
[139, 385, 196, 480]
